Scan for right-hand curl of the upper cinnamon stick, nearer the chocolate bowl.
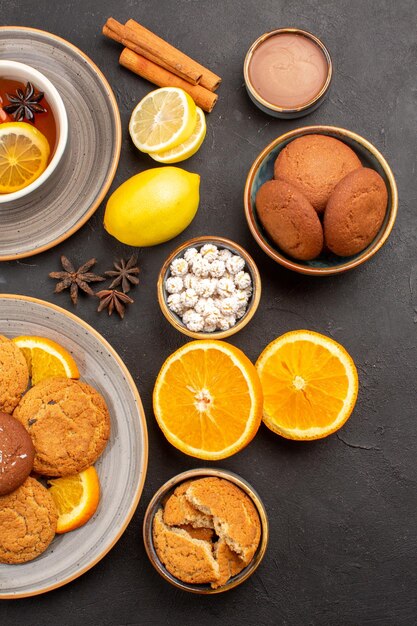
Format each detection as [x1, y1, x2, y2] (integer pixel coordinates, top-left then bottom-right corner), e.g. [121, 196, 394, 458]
[125, 20, 222, 91]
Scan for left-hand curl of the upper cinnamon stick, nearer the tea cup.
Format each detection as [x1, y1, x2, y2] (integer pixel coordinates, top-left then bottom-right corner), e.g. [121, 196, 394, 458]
[103, 17, 202, 85]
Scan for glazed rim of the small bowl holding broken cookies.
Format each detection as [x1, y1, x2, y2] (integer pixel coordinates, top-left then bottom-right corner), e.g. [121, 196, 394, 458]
[143, 467, 269, 595]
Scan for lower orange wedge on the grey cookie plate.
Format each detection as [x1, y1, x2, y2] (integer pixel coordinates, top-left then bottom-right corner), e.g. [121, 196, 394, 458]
[48, 466, 100, 534]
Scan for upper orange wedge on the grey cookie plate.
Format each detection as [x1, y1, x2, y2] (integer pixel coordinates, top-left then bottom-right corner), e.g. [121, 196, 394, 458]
[13, 335, 80, 385]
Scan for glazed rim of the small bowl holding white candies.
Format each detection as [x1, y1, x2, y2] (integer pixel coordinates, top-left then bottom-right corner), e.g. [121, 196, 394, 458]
[157, 235, 262, 339]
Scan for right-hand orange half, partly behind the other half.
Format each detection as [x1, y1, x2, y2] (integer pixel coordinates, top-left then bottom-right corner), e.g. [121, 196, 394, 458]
[256, 330, 358, 439]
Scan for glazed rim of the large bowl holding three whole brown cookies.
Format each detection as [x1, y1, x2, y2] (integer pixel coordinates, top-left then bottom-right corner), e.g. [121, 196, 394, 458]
[244, 125, 398, 276]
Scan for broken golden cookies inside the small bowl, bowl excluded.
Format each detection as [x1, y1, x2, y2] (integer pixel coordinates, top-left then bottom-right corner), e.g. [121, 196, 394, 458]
[153, 477, 261, 589]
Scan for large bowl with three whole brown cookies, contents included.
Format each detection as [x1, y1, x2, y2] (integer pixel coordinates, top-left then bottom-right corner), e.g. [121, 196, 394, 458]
[244, 126, 398, 276]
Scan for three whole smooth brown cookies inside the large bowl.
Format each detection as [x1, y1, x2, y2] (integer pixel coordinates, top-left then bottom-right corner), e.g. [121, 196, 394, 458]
[256, 135, 388, 261]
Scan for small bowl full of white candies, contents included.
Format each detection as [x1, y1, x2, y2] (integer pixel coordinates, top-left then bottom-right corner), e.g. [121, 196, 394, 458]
[158, 237, 261, 339]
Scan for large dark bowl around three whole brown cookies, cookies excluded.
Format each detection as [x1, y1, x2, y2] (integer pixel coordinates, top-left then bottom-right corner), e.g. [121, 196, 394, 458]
[244, 126, 398, 276]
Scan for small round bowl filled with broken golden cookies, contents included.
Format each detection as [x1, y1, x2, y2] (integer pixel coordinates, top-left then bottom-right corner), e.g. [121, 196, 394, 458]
[143, 468, 268, 595]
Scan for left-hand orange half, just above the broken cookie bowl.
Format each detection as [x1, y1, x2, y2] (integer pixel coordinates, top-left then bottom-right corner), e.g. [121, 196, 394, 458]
[153, 340, 262, 460]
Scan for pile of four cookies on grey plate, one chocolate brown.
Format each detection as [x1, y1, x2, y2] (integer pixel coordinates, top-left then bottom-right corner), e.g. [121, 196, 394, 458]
[0, 336, 110, 563]
